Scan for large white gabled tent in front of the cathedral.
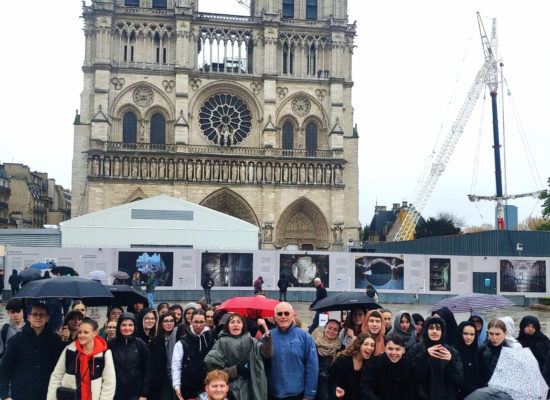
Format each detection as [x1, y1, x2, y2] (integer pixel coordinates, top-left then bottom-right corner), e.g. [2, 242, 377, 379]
[61, 195, 259, 250]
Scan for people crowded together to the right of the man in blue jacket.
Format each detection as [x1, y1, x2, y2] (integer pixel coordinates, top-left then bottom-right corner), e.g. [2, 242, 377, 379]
[313, 307, 550, 400]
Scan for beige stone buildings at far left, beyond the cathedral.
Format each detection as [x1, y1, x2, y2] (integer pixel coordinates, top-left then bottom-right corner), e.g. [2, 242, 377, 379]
[0, 163, 71, 229]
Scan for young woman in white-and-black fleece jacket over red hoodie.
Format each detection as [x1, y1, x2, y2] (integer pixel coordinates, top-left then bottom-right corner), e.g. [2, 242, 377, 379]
[47, 318, 116, 400]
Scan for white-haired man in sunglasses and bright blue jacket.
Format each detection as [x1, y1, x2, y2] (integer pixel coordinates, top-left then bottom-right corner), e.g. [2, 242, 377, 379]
[267, 302, 319, 400]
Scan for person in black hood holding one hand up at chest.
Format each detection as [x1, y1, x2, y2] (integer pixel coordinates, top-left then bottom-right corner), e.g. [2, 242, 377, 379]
[409, 317, 464, 400]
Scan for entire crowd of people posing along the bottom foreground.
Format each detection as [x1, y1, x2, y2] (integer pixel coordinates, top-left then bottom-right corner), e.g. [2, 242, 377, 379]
[0, 299, 550, 400]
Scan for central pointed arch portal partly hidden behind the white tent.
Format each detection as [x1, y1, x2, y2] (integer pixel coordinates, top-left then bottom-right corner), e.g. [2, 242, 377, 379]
[200, 188, 260, 226]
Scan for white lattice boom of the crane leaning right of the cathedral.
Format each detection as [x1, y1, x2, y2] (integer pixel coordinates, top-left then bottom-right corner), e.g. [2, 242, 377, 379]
[389, 12, 500, 241]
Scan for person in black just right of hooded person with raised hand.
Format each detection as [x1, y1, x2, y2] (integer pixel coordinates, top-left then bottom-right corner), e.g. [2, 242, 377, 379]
[456, 321, 478, 399]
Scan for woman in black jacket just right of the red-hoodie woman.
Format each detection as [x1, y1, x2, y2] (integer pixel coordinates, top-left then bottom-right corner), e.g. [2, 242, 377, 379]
[108, 313, 151, 400]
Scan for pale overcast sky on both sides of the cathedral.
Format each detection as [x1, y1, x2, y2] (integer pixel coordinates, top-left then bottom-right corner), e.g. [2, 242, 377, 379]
[0, 0, 550, 230]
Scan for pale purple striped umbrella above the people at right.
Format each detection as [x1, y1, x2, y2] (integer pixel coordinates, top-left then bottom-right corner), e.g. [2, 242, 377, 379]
[432, 293, 515, 313]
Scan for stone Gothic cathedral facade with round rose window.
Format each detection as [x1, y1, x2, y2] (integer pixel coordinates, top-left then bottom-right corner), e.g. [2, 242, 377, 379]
[72, 0, 359, 250]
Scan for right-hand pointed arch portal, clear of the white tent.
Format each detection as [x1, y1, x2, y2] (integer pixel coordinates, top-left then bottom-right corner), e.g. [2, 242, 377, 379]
[276, 197, 330, 250]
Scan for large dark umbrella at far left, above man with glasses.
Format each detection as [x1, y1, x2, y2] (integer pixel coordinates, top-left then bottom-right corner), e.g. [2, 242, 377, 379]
[14, 276, 113, 299]
